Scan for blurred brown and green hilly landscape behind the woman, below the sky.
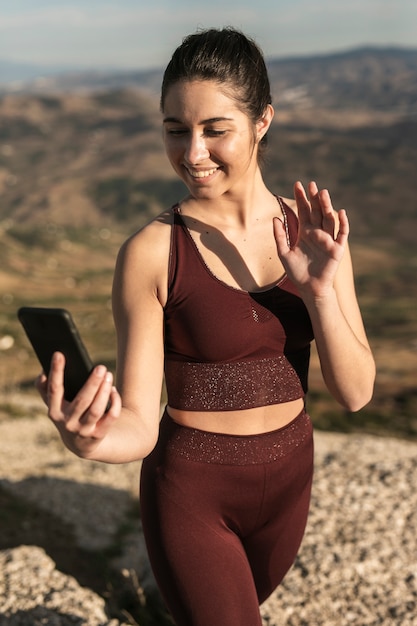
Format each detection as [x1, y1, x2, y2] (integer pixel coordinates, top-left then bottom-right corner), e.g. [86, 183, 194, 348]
[0, 49, 417, 437]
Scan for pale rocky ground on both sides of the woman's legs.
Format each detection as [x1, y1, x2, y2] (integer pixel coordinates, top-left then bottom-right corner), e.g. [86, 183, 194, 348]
[0, 392, 417, 626]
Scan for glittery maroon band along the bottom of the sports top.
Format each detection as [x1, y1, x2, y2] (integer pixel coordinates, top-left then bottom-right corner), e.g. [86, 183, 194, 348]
[165, 355, 304, 411]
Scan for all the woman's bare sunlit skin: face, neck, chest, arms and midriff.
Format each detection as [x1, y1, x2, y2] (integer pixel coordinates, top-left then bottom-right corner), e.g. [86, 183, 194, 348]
[37, 81, 375, 462]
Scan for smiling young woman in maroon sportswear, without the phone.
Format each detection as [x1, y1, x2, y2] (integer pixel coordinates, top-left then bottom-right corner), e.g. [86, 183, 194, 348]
[38, 29, 375, 626]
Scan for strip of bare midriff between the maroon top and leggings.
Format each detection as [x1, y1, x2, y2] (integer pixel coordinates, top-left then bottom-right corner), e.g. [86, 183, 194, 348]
[167, 397, 304, 435]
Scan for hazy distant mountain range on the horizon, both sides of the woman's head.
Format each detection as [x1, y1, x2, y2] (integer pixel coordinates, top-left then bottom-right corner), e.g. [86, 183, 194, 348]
[0, 46, 417, 110]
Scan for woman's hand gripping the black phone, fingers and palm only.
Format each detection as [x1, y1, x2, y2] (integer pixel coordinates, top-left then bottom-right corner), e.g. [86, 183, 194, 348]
[36, 352, 121, 457]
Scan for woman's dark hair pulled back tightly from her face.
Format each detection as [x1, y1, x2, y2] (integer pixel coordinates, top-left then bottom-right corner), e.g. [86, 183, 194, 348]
[161, 28, 272, 149]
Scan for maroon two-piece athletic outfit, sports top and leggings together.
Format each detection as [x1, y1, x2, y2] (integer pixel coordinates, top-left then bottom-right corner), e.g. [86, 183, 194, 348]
[140, 198, 313, 626]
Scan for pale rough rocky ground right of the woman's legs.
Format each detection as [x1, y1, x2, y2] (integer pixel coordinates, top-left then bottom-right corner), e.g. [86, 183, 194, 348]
[262, 432, 417, 626]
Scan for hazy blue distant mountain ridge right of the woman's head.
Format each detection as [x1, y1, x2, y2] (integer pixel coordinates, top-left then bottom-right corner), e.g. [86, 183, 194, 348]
[269, 47, 417, 113]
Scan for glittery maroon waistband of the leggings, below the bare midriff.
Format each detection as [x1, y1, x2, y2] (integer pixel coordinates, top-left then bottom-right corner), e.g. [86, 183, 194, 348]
[159, 410, 313, 465]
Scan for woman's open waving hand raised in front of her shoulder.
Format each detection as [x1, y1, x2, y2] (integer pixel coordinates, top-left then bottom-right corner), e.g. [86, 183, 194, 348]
[274, 182, 349, 298]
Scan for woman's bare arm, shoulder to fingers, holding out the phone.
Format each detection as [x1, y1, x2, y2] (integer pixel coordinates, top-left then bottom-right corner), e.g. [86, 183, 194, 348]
[38, 217, 169, 463]
